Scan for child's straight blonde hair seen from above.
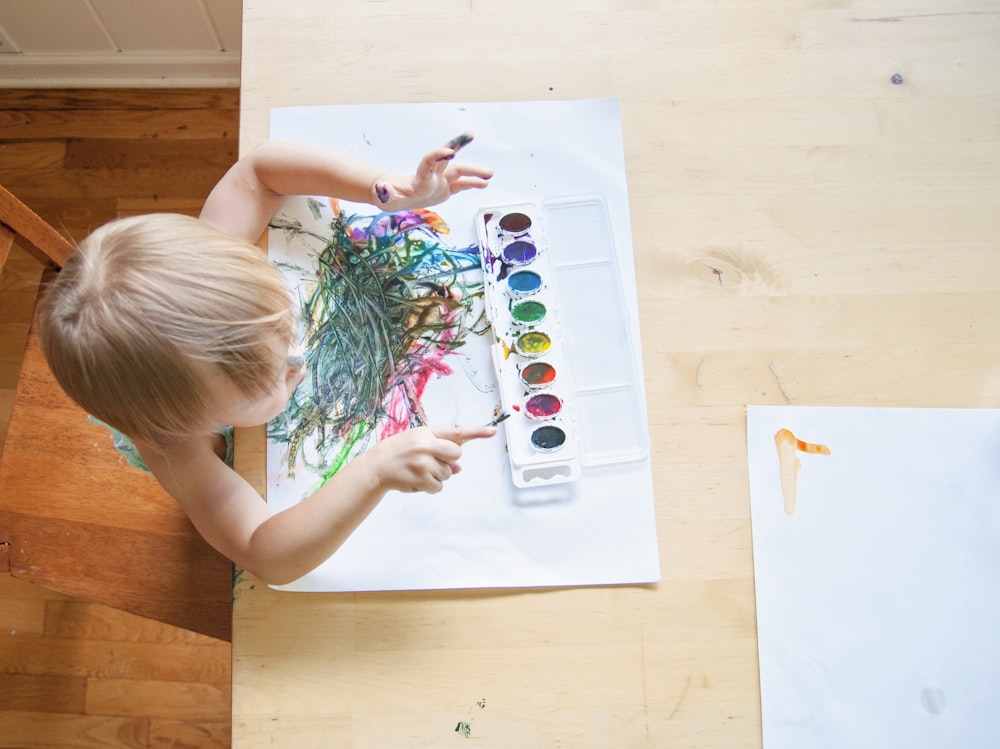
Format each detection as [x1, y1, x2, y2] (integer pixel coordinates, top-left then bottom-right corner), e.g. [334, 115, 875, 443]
[39, 214, 295, 446]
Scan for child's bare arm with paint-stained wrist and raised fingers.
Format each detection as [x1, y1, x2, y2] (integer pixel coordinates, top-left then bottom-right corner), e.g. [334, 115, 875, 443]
[201, 136, 493, 242]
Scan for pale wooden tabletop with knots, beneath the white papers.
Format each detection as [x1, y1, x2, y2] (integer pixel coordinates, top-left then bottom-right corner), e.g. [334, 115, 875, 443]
[233, 0, 1000, 749]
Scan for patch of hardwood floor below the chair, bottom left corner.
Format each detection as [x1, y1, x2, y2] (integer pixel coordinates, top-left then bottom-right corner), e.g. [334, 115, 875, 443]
[0, 575, 230, 749]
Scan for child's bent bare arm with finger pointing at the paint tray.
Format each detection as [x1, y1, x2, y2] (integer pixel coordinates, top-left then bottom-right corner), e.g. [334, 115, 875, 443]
[140, 426, 496, 584]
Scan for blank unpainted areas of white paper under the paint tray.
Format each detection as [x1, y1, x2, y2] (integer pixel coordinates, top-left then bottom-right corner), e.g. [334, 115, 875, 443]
[268, 99, 659, 591]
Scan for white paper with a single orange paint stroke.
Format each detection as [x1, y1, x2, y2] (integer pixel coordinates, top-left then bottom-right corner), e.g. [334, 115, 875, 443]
[747, 406, 1000, 749]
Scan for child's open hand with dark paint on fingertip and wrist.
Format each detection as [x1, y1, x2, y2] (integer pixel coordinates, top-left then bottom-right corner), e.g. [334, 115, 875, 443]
[372, 133, 493, 211]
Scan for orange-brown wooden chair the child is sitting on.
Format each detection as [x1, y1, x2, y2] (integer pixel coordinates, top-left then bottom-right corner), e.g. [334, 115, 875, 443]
[0, 187, 233, 640]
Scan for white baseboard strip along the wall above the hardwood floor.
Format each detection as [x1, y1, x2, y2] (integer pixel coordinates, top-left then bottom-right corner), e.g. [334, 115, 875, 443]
[0, 52, 240, 88]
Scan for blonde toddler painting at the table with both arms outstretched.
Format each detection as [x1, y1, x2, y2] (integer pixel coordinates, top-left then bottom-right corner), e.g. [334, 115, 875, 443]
[39, 136, 496, 584]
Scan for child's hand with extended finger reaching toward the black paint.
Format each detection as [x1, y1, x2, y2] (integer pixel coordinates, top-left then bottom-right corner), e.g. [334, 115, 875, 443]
[364, 425, 497, 494]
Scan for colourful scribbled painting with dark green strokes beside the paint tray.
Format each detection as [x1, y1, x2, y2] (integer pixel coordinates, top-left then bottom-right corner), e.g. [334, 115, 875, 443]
[268, 201, 489, 485]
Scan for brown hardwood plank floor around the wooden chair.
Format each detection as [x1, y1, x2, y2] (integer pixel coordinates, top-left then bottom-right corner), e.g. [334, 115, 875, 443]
[0, 89, 239, 749]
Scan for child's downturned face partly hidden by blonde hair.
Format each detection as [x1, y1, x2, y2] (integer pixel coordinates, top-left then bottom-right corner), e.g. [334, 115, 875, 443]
[209, 343, 306, 427]
